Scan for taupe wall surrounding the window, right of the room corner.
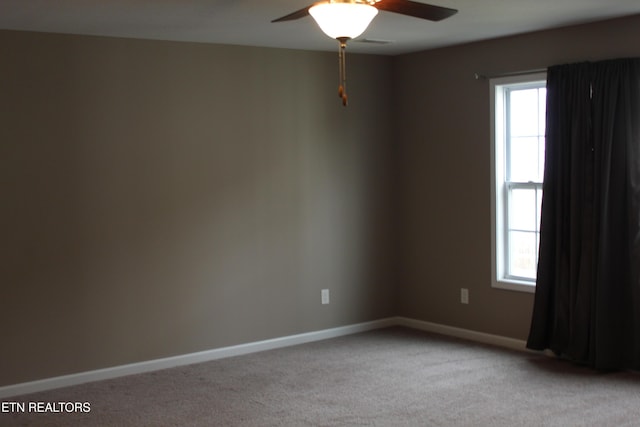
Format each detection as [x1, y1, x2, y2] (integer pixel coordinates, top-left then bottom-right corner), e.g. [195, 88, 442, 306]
[394, 16, 640, 339]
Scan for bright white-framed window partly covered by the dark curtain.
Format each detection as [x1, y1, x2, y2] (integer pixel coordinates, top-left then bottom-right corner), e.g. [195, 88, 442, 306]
[491, 73, 547, 292]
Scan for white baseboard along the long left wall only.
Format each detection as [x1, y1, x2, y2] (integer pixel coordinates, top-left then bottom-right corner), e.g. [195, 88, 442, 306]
[0, 318, 397, 399]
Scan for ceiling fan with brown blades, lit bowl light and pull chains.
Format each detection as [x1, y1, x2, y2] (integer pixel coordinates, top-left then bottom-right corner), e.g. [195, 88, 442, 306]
[271, 0, 458, 107]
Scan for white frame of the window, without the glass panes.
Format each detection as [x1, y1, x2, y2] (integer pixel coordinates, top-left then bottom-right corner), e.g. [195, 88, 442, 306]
[489, 72, 547, 293]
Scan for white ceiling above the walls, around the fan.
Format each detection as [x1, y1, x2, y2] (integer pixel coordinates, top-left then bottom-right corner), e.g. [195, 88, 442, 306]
[0, 0, 640, 55]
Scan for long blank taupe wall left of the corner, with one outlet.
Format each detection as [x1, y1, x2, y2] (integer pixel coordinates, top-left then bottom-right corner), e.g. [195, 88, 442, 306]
[0, 31, 395, 386]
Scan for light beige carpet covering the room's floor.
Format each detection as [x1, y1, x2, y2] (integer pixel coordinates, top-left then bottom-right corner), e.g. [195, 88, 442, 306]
[0, 327, 640, 427]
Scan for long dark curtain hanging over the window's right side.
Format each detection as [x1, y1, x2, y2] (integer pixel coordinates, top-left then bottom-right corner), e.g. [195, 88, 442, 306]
[527, 58, 640, 370]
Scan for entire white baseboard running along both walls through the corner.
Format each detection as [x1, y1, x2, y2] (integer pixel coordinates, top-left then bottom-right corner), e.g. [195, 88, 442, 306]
[0, 317, 526, 399]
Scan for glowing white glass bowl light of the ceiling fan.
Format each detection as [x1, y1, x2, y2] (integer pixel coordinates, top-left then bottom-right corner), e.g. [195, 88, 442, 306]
[309, 1, 378, 39]
